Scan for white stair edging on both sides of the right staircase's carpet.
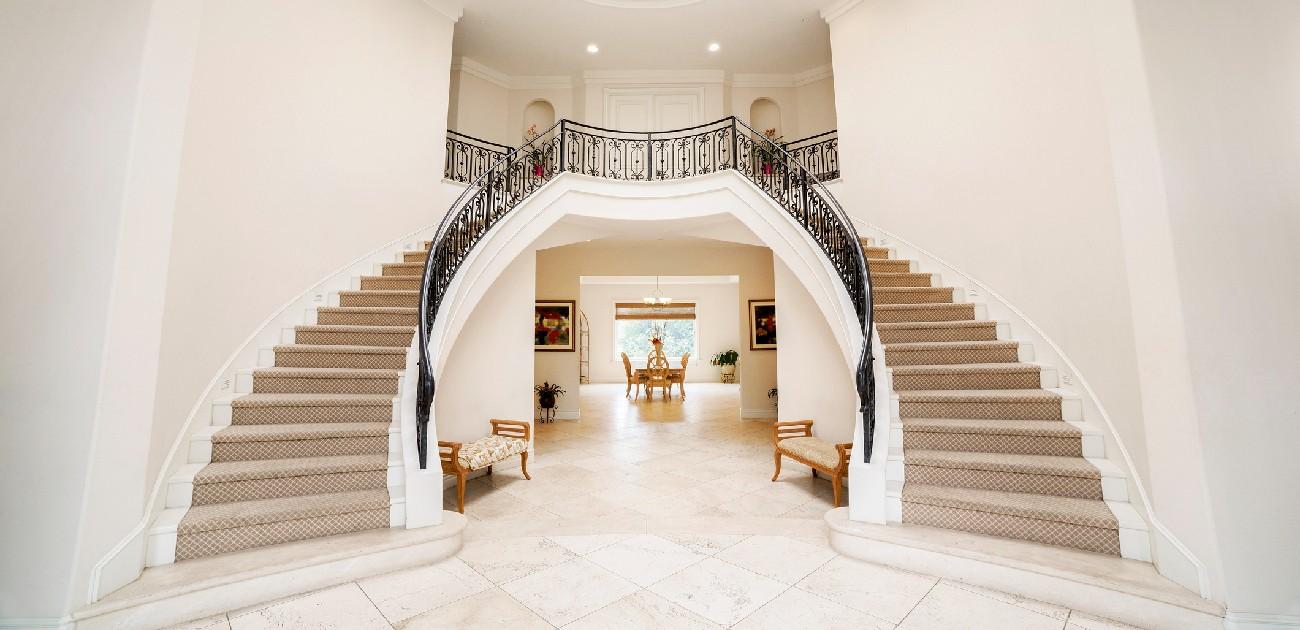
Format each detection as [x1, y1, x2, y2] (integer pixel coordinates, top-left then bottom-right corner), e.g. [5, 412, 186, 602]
[852, 217, 1209, 596]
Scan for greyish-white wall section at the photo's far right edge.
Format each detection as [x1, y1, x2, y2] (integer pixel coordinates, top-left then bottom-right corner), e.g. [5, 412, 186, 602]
[1131, 0, 1300, 615]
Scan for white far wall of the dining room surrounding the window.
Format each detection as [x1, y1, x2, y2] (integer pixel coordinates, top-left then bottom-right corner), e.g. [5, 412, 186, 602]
[579, 282, 748, 383]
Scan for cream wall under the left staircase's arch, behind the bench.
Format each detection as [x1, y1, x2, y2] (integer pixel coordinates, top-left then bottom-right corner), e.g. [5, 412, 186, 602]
[434, 252, 536, 442]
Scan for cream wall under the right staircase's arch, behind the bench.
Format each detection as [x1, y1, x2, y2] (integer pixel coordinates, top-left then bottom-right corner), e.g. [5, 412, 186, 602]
[772, 258, 858, 443]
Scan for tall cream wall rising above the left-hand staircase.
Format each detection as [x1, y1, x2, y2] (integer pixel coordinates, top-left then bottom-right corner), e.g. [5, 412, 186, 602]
[150, 0, 451, 496]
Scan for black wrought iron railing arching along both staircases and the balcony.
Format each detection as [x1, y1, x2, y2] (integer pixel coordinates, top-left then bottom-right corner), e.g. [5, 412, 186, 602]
[416, 117, 876, 469]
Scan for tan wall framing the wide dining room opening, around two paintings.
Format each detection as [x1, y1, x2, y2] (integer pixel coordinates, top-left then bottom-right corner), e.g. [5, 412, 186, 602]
[533, 242, 776, 414]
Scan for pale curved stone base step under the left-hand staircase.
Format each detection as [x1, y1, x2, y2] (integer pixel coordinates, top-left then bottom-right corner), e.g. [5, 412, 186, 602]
[73, 512, 467, 630]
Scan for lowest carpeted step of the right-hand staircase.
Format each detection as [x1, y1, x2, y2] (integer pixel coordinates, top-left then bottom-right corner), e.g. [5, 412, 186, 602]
[902, 483, 1119, 556]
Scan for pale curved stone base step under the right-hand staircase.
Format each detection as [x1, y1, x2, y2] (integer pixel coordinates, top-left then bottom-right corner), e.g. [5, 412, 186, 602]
[826, 508, 1223, 630]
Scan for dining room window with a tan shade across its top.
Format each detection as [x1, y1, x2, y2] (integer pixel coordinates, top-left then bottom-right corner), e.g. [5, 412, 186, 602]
[614, 301, 698, 361]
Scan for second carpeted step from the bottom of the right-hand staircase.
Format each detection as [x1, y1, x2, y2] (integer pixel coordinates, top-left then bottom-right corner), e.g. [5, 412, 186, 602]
[904, 449, 1102, 500]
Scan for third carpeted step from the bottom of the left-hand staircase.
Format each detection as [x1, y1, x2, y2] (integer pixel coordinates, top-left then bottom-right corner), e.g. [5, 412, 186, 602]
[212, 422, 390, 461]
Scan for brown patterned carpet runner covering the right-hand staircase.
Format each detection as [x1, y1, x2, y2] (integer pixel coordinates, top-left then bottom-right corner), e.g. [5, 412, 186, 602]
[862, 239, 1119, 556]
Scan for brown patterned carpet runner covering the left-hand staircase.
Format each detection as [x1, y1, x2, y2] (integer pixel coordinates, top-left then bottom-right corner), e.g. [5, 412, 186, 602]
[167, 242, 425, 561]
